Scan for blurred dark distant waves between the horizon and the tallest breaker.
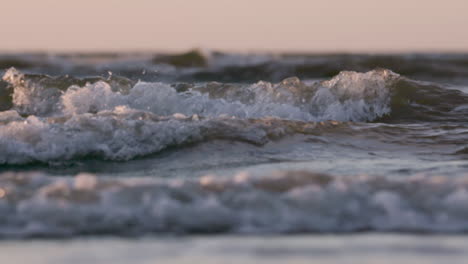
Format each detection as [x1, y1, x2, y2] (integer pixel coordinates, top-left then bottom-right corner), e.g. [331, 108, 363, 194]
[0, 50, 468, 82]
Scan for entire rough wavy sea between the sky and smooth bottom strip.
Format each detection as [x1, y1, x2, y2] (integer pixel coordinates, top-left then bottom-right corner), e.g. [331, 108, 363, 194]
[0, 51, 468, 238]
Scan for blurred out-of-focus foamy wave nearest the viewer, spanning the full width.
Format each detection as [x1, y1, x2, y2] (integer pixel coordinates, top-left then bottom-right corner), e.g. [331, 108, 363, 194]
[0, 171, 468, 238]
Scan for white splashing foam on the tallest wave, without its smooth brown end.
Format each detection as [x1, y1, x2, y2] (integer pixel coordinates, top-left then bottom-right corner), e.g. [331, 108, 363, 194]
[3, 69, 398, 121]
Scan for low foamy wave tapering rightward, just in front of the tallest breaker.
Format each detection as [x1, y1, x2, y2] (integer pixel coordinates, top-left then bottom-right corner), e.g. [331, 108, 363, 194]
[0, 106, 348, 164]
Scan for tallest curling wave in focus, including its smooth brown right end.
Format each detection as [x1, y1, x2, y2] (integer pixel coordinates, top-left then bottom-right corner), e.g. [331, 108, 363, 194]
[0, 68, 468, 122]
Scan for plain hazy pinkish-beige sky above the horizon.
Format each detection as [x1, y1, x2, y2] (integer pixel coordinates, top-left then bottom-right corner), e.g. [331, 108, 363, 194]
[0, 0, 468, 52]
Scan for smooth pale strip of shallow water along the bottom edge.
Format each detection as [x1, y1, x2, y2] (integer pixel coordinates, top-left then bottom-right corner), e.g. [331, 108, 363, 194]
[0, 234, 468, 264]
